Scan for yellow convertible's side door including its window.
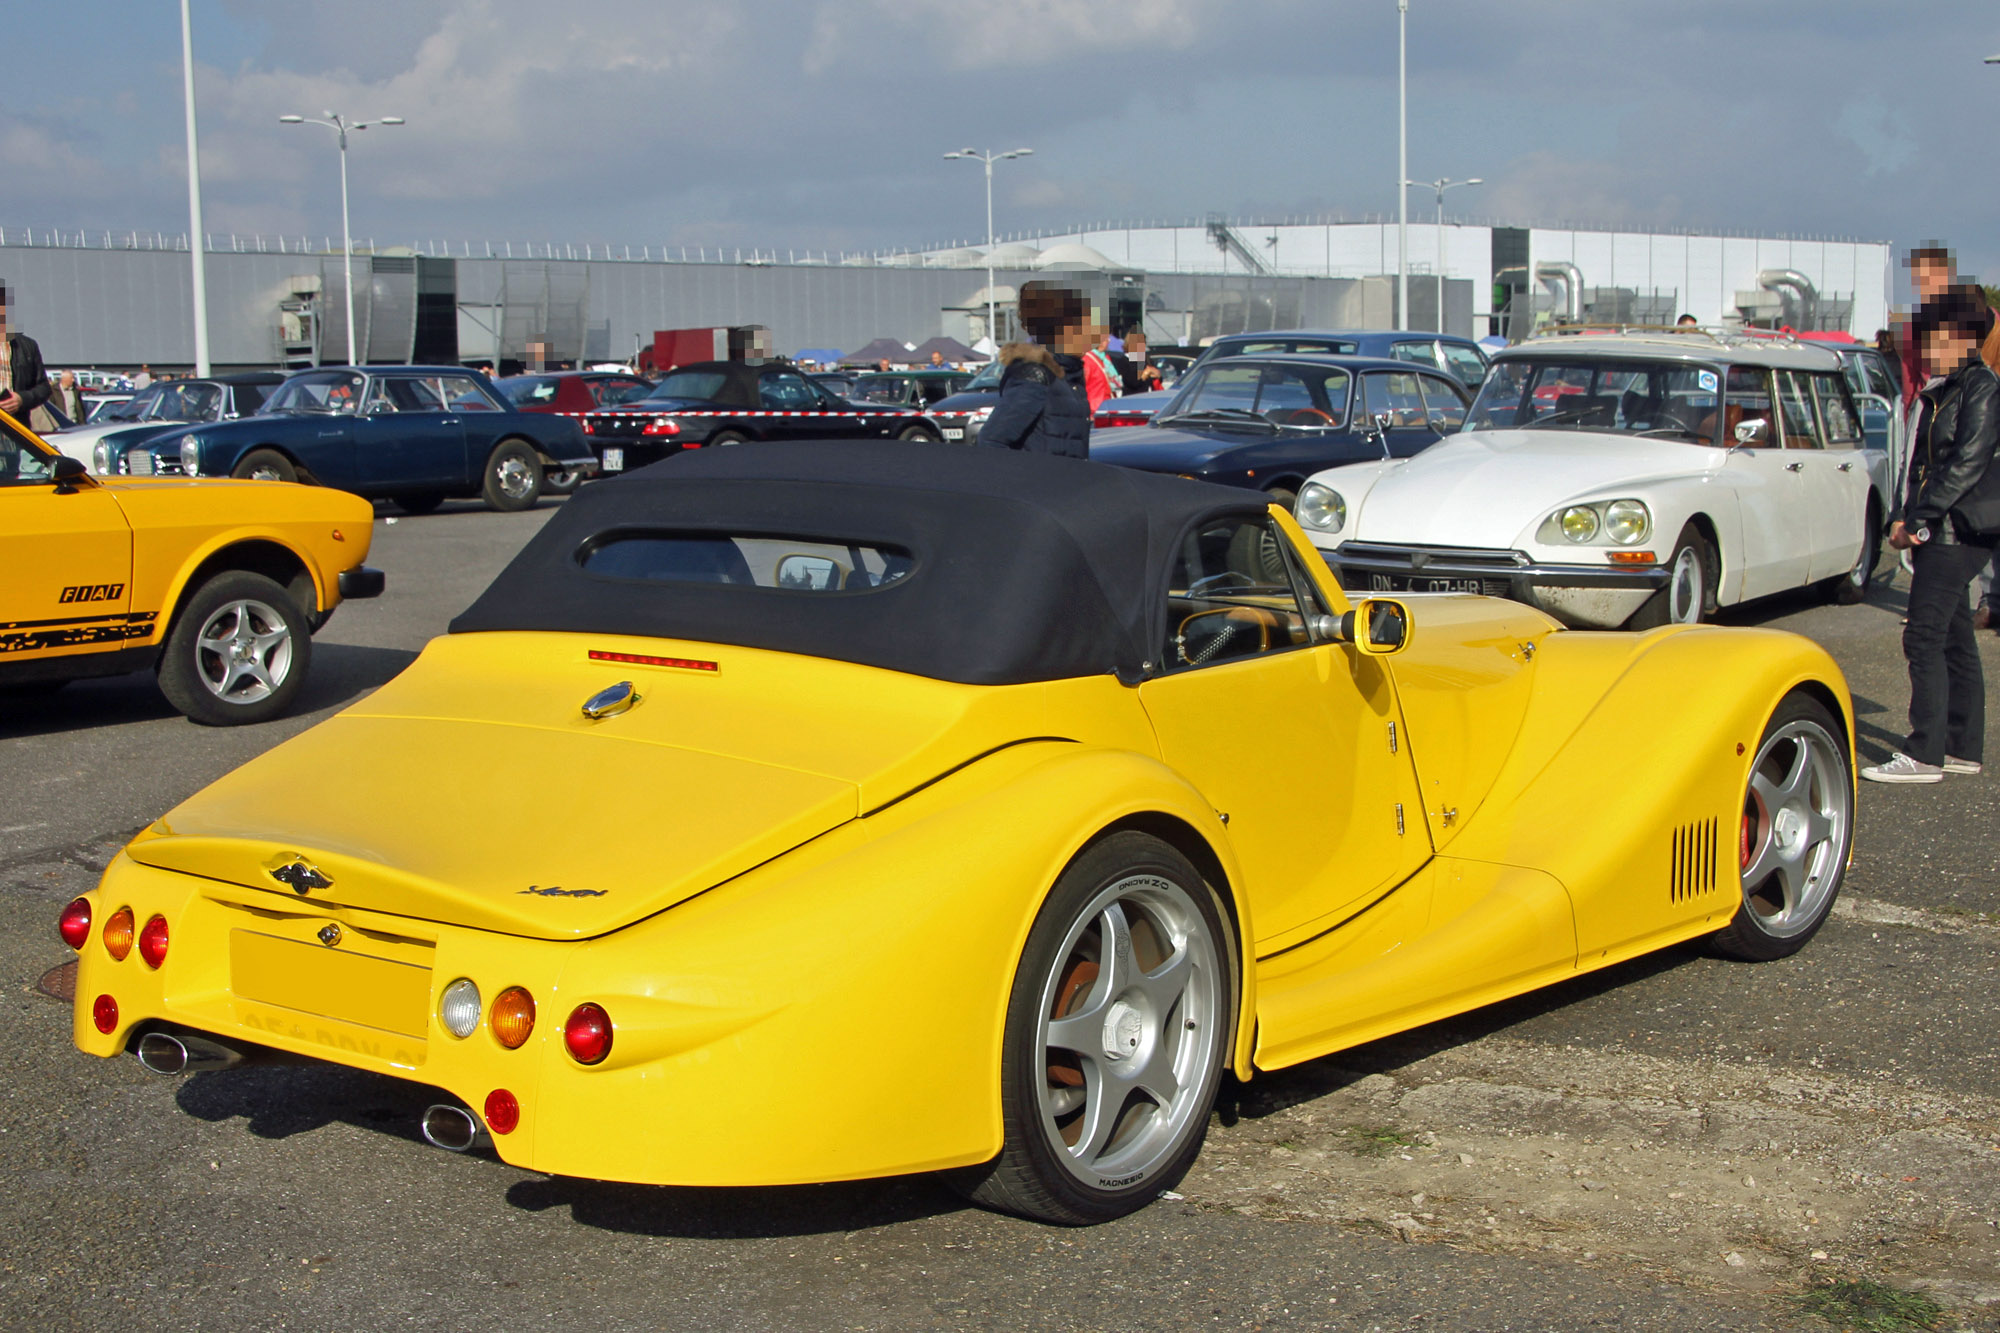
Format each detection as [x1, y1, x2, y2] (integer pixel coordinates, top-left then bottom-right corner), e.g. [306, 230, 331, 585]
[1138, 514, 1430, 947]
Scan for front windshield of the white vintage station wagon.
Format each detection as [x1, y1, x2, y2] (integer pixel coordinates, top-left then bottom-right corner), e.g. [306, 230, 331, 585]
[1466, 356, 1722, 444]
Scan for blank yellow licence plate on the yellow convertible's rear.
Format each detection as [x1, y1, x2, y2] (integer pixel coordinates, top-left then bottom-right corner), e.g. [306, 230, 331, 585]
[230, 931, 430, 1039]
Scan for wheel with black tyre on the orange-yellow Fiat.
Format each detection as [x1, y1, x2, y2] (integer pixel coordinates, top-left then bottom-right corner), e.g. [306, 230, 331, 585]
[158, 570, 312, 727]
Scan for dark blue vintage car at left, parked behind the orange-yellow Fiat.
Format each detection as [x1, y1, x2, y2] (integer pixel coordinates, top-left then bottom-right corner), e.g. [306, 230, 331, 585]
[116, 366, 598, 514]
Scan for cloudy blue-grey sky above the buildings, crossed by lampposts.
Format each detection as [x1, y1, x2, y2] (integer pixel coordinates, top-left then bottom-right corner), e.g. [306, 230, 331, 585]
[15, 0, 2000, 294]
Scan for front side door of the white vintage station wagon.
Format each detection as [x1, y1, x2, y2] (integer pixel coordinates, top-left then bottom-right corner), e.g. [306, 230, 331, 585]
[1722, 366, 1812, 600]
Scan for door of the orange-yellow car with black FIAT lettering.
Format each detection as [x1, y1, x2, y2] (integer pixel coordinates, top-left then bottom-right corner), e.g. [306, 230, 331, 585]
[0, 426, 133, 673]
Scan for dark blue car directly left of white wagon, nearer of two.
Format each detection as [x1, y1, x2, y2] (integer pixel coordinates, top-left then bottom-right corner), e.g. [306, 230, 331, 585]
[1090, 354, 1466, 508]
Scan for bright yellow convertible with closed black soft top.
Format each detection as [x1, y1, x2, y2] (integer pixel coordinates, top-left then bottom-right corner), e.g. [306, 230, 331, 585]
[60, 442, 1854, 1223]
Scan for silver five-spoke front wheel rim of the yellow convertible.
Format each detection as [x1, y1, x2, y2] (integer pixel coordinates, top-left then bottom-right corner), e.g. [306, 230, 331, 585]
[1738, 719, 1854, 939]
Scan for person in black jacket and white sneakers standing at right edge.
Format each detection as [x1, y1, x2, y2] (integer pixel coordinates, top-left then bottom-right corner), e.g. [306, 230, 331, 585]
[1862, 286, 2000, 783]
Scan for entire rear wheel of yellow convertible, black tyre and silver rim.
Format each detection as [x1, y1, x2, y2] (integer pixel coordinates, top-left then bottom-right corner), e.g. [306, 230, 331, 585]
[948, 831, 1240, 1225]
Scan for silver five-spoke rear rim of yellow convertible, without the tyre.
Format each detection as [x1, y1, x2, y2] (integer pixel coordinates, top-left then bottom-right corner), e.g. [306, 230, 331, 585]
[1036, 875, 1222, 1189]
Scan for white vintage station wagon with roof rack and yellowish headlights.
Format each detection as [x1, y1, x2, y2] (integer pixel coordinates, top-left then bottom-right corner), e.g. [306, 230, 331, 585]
[1298, 332, 1894, 628]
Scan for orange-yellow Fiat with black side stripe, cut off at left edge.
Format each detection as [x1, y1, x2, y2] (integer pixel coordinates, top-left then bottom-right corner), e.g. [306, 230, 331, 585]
[0, 412, 384, 727]
